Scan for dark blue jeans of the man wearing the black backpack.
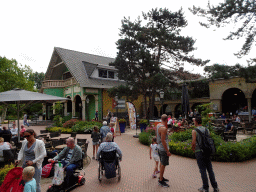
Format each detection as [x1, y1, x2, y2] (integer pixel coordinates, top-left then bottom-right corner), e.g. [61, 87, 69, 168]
[195, 152, 218, 190]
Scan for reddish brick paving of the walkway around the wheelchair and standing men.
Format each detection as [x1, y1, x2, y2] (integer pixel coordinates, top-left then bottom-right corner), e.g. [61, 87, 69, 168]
[11, 126, 256, 192]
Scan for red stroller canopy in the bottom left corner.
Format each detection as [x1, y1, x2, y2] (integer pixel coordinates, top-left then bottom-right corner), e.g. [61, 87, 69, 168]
[0, 167, 25, 192]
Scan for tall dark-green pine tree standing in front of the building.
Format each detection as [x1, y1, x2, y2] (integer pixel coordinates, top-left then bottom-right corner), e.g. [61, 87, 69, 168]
[113, 8, 208, 117]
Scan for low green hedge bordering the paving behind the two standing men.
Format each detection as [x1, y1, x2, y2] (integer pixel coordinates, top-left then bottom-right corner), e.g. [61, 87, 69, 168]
[139, 129, 256, 162]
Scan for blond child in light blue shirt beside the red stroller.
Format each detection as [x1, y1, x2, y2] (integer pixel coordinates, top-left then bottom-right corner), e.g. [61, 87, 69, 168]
[22, 166, 36, 192]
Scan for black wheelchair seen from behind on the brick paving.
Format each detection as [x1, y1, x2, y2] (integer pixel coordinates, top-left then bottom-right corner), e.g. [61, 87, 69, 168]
[98, 150, 121, 182]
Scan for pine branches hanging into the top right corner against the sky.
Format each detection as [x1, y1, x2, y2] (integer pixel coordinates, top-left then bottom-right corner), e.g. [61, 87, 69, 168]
[190, 0, 256, 57]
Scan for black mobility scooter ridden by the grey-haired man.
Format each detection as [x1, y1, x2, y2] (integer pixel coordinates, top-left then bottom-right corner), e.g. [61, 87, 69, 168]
[47, 159, 85, 192]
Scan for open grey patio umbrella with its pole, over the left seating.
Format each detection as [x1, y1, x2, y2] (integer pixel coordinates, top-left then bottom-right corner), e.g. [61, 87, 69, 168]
[0, 89, 68, 141]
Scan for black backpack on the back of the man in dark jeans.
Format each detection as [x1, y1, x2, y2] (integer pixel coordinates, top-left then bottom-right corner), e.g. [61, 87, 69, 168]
[195, 128, 216, 157]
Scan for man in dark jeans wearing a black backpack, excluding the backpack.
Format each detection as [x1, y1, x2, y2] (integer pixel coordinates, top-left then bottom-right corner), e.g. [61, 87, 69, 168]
[192, 116, 219, 192]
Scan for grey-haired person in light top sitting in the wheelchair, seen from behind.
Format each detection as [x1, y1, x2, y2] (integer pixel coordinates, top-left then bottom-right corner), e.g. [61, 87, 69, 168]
[96, 133, 122, 161]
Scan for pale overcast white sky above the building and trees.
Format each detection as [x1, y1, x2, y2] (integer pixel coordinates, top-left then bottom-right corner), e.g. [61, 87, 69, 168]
[0, 0, 255, 74]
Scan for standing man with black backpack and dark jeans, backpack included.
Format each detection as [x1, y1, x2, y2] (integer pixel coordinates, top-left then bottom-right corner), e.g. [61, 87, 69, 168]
[192, 116, 219, 192]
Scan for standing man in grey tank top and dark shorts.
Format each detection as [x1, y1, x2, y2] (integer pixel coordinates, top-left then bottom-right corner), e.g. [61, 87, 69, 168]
[156, 114, 171, 187]
